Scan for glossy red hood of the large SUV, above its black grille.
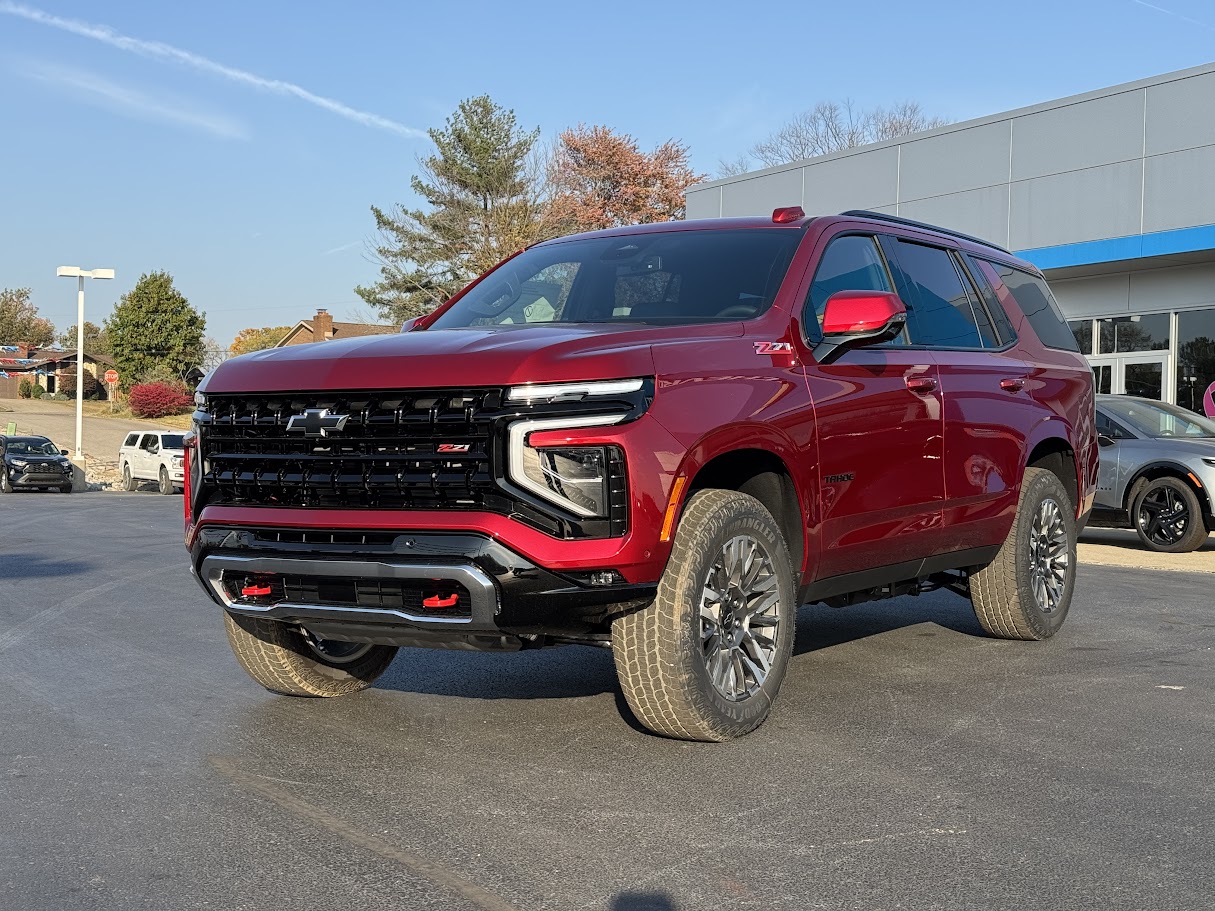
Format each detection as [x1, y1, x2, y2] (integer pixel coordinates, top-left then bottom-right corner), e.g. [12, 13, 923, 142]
[199, 323, 742, 394]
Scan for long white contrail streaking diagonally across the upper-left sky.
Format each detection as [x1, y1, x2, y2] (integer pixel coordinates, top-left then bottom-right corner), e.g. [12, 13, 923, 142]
[0, 0, 426, 138]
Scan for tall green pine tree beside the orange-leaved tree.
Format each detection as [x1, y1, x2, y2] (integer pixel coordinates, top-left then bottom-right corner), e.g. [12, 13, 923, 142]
[355, 95, 553, 322]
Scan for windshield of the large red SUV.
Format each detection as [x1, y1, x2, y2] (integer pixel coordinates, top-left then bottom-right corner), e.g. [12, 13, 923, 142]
[429, 228, 802, 329]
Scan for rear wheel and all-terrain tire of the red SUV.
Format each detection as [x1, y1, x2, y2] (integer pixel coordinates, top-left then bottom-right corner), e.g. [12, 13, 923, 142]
[970, 468, 1076, 640]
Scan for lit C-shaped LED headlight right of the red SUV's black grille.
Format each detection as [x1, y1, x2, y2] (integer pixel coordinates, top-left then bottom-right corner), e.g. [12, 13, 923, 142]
[509, 414, 625, 519]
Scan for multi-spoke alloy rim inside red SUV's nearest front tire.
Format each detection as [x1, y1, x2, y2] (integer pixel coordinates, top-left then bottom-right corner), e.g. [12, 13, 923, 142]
[700, 534, 781, 702]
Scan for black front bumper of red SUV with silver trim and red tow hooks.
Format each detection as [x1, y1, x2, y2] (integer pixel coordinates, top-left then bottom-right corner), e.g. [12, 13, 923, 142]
[191, 526, 657, 649]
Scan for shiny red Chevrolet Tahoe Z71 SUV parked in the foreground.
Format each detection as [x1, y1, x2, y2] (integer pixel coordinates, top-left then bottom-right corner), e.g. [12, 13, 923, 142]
[186, 208, 1097, 740]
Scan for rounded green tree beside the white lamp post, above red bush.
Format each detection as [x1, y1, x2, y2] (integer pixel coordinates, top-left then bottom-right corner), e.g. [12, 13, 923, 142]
[104, 272, 207, 389]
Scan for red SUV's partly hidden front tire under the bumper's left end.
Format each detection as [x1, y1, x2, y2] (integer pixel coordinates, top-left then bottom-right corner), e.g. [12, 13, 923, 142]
[224, 611, 396, 696]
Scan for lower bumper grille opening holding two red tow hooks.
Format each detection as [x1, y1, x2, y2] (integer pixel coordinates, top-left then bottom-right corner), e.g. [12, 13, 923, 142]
[222, 572, 473, 619]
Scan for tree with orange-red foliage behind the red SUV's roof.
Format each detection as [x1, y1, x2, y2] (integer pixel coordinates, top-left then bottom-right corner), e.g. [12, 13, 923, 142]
[549, 124, 708, 231]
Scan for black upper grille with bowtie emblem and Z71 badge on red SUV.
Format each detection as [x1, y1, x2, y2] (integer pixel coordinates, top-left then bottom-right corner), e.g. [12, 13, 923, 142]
[194, 389, 510, 513]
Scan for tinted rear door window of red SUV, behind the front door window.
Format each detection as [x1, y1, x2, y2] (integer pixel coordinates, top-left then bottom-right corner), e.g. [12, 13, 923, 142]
[898, 241, 983, 347]
